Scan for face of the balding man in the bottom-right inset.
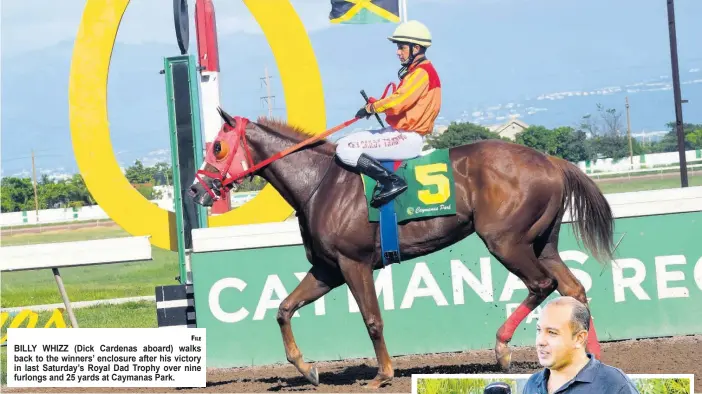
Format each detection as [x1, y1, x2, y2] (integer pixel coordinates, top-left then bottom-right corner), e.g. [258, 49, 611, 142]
[536, 305, 587, 370]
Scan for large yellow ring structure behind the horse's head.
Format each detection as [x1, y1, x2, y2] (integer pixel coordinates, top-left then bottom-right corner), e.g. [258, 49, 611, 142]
[69, 0, 326, 251]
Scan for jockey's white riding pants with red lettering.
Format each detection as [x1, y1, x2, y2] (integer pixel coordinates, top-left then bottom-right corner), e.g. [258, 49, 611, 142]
[336, 127, 424, 167]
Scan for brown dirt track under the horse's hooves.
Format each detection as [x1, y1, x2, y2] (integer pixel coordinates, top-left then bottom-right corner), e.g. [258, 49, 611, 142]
[3, 335, 702, 393]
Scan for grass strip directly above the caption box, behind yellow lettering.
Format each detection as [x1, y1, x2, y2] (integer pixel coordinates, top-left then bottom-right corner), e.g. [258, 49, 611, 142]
[0, 302, 157, 384]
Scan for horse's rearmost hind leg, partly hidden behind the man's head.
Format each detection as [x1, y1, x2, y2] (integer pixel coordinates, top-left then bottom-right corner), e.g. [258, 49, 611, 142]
[539, 240, 600, 359]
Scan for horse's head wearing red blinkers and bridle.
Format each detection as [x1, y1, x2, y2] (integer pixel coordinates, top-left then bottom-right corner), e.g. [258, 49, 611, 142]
[189, 108, 253, 207]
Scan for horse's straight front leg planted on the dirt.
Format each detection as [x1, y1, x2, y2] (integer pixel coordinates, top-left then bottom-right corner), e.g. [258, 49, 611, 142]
[339, 257, 394, 389]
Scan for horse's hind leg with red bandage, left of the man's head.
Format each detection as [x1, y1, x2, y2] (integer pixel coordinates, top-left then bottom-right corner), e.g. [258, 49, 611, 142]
[485, 234, 557, 370]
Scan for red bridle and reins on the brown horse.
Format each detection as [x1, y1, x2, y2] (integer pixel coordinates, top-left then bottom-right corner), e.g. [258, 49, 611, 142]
[195, 116, 358, 201]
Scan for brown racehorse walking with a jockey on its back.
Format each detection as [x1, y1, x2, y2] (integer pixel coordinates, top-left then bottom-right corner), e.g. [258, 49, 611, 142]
[190, 109, 614, 388]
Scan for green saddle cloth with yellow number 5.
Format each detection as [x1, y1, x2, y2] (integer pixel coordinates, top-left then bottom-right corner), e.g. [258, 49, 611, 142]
[361, 149, 456, 223]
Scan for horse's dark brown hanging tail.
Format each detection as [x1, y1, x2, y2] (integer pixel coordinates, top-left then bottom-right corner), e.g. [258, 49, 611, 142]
[551, 157, 614, 264]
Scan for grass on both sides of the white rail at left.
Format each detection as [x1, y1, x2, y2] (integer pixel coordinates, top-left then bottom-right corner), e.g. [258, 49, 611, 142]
[0, 228, 178, 308]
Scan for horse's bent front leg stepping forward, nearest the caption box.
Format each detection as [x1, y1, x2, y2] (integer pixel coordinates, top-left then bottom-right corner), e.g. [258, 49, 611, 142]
[276, 265, 344, 386]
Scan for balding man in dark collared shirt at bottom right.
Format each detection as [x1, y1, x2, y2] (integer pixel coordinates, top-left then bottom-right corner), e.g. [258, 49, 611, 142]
[523, 297, 638, 394]
